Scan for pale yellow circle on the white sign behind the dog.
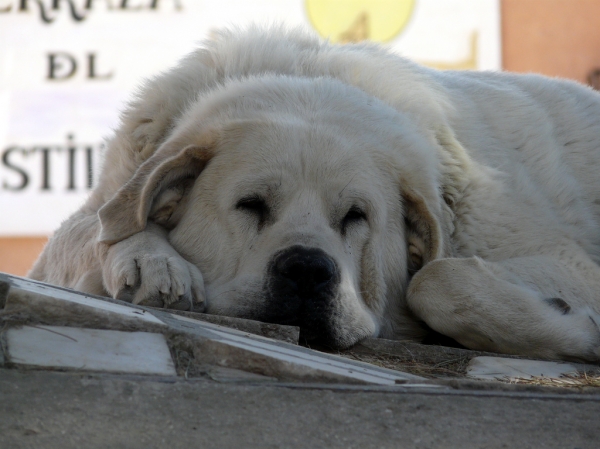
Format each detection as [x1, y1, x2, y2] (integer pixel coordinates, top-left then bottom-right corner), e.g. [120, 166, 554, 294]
[306, 0, 415, 43]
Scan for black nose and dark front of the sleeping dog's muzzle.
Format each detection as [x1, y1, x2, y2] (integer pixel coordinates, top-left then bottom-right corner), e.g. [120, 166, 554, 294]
[262, 245, 340, 342]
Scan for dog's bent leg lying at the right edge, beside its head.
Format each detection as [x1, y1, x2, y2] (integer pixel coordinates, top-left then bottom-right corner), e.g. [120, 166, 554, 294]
[407, 256, 600, 361]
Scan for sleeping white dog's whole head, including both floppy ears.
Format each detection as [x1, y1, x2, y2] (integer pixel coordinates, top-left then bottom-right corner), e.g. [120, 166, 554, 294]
[100, 77, 443, 347]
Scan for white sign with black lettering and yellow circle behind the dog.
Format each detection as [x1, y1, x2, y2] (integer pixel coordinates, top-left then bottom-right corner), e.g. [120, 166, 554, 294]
[0, 0, 500, 236]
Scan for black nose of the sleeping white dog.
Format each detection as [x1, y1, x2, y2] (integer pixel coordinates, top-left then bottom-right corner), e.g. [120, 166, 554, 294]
[274, 246, 337, 295]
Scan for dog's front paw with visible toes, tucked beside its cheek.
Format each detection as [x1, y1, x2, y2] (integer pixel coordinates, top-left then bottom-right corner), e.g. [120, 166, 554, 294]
[102, 231, 205, 312]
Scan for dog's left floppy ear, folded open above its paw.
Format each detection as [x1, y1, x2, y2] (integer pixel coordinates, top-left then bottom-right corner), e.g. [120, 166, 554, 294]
[98, 132, 216, 244]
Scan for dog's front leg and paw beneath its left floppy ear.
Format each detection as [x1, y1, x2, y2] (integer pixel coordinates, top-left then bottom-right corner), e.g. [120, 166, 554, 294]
[28, 211, 204, 311]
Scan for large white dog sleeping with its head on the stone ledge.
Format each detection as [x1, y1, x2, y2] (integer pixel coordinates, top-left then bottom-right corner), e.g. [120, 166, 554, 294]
[30, 25, 600, 361]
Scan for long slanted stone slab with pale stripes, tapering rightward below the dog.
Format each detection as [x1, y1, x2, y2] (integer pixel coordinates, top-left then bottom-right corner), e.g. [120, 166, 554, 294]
[0, 276, 422, 385]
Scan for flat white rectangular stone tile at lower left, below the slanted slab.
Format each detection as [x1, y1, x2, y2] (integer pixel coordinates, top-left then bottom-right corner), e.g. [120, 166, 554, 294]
[5, 326, 177, 376]
